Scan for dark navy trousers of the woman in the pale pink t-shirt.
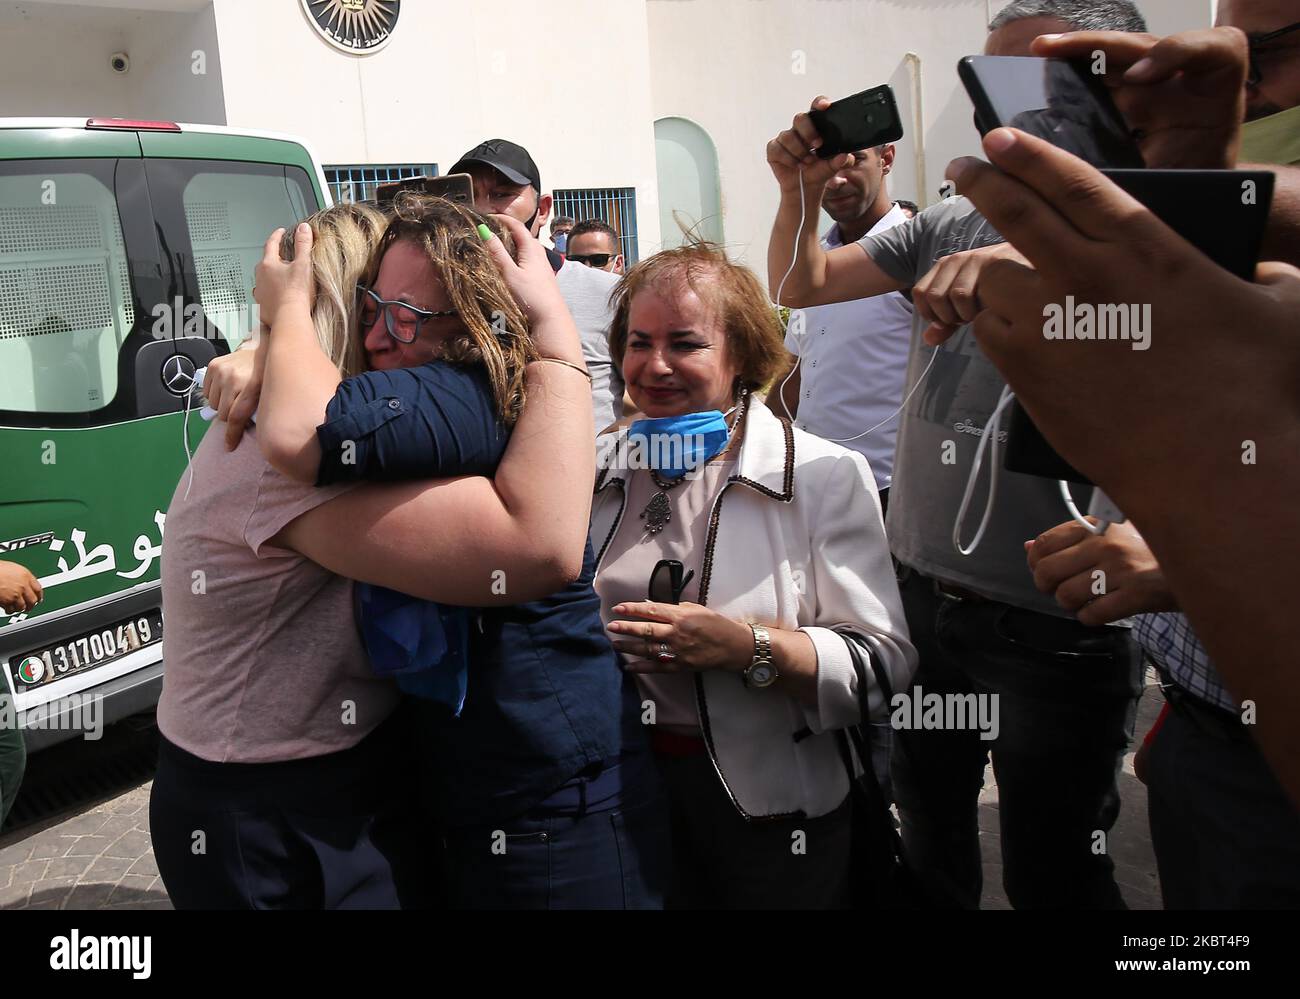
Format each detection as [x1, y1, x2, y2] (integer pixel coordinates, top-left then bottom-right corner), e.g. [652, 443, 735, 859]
[150, 722, 437, 909]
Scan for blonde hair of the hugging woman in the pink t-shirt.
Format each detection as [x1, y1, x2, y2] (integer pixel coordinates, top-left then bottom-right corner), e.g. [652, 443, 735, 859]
[280, 202, 389, 379]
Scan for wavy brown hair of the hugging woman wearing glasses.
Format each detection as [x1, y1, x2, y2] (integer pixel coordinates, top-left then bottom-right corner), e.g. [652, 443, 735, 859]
[367, 191, 538, 425]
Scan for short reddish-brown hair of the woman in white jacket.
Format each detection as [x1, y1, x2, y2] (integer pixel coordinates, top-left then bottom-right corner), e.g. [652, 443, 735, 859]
[610, 242, 787, 392]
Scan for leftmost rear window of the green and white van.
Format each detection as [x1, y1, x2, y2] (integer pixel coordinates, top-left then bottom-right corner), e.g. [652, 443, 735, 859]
[0, 160, 135, 414]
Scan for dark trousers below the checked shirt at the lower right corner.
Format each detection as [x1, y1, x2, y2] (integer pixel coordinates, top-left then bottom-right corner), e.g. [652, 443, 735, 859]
[1147, 708, 1300, 909]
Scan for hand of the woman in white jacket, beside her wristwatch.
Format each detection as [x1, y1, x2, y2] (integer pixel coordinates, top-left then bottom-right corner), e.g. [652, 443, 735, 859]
[608, 601, 754, 673]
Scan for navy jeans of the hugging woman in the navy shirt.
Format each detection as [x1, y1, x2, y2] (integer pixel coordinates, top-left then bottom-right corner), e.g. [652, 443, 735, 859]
[443, 753, 670, 909]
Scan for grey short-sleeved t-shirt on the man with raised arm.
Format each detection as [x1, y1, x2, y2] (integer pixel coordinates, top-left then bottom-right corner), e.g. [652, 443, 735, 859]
[859, 198, 1088, 617]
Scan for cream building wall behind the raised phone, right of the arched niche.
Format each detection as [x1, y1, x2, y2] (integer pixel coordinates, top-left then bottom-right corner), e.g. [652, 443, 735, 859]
[642, 0, 1212, 262]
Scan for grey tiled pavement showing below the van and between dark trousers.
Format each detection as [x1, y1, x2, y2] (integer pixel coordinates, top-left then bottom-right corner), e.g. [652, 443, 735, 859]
[0, 686, 1161, 909]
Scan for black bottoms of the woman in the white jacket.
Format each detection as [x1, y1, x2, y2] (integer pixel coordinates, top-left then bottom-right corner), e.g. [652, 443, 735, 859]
[658, 754, 850, 909]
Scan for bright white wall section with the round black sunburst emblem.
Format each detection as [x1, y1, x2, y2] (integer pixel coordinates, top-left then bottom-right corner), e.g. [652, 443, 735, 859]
[215, 0, 659, 254]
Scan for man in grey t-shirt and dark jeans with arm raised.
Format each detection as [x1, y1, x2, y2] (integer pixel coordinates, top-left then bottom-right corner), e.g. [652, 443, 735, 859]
[767, 0, 1145, 908]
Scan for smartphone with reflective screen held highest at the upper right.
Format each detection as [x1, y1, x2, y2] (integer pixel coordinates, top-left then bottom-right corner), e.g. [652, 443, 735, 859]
[957, 56, 1145, 168]
